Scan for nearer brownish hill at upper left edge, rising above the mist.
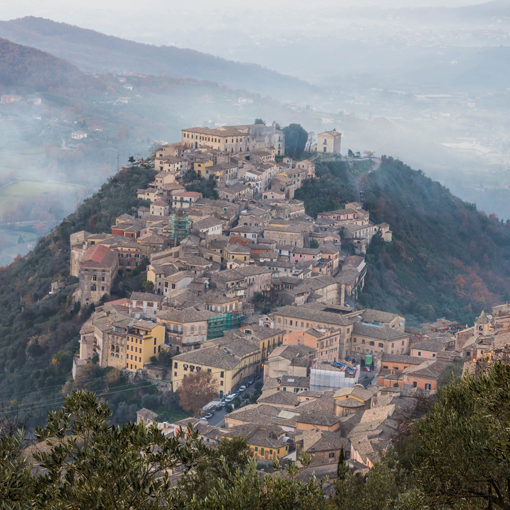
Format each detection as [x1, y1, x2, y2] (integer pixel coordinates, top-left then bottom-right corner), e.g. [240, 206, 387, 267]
[0, 39, 106, 92]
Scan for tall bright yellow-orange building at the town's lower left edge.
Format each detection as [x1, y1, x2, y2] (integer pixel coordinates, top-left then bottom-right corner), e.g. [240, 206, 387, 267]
[126, 320, 166, 371]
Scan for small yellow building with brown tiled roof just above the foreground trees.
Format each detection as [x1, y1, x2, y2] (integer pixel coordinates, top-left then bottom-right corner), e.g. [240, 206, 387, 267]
[222, 425, 289, 460]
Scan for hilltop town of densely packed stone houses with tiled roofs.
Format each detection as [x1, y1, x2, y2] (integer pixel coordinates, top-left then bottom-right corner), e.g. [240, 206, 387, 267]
[62, 123, 510, 474]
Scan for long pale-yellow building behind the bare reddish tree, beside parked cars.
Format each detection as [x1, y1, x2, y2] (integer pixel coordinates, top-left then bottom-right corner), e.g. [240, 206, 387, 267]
[172, 338, 260, 398]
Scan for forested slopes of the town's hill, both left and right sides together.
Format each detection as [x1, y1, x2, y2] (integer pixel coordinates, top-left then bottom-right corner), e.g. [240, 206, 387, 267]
[0, 158, 510, 422]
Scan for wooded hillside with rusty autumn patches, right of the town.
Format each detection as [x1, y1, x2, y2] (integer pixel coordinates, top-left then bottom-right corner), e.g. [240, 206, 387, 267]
[296, 158, 510, 324]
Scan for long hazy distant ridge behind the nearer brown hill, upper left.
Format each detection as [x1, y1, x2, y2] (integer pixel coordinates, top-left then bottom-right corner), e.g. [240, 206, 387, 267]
[0, 17, 314, 100]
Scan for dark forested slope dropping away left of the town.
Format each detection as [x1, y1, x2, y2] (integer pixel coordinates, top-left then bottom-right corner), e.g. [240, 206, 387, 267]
[0, 167, 155, 422]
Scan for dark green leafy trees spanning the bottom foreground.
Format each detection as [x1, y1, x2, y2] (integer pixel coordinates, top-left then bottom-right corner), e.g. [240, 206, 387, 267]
[0, 363, 510, 510]
